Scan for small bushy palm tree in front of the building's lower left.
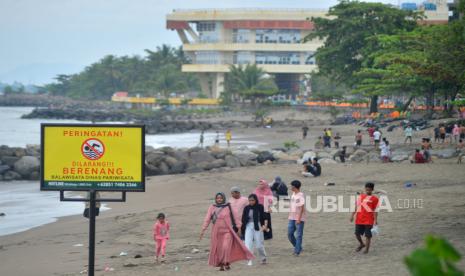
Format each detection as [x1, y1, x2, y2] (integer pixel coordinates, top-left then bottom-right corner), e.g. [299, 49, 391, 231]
[225, 64, 278, 103]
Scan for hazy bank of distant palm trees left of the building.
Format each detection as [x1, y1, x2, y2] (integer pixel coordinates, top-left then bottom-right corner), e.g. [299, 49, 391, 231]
[46, 45, 200, 100]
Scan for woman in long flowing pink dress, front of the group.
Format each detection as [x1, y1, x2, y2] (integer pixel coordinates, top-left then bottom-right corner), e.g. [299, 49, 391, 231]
[199, 193, 255, 271]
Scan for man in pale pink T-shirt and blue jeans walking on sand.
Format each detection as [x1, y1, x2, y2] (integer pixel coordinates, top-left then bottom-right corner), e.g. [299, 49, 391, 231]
[287, 180, 306, 257]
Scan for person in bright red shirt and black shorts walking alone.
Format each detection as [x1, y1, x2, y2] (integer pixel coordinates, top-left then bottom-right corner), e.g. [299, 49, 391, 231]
[350, 182, 379, 254]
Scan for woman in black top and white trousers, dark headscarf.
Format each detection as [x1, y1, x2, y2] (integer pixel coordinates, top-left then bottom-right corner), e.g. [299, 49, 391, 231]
[241, 194, 268, 265]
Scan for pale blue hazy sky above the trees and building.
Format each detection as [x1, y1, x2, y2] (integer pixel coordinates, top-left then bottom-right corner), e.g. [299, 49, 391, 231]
[0, 0, 398, 85]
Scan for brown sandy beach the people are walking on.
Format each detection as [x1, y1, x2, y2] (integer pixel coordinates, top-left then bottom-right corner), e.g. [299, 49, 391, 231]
[0, 121, 465, 275]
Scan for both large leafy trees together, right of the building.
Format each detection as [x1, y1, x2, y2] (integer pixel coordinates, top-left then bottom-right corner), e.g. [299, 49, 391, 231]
[306, 0, 465, 113]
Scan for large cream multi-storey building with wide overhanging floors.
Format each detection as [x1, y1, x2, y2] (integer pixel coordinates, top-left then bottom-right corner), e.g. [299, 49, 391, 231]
[167, 9, 327, 98]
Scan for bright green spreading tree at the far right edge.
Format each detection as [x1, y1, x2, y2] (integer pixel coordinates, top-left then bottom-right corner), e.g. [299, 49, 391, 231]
[355, 21, 465, 114]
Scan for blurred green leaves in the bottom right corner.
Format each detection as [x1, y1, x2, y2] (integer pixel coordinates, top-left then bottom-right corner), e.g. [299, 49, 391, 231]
[404, 236, 464, 276]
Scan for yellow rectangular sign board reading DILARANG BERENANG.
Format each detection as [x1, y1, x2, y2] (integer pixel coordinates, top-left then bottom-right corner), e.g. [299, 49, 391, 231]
[41, 124, 145, 191]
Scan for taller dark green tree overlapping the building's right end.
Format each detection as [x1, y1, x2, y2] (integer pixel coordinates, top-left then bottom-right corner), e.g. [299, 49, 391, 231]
[305, 0, 420, 112]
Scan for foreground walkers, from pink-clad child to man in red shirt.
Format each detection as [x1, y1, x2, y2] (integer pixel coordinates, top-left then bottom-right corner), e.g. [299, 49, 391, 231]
[153, 177, 379, 271]
